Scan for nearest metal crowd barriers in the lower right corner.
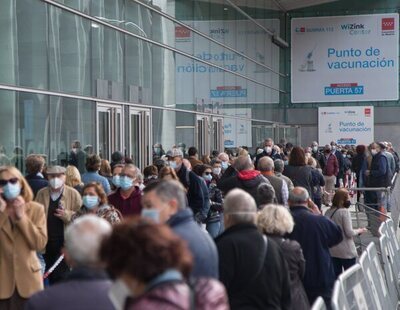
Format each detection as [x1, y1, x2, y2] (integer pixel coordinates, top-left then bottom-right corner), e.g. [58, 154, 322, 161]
[320, 219, 400, 310]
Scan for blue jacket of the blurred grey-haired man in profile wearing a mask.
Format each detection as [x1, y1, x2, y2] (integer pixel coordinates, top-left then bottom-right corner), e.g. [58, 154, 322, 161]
[167, 208, 218, 279]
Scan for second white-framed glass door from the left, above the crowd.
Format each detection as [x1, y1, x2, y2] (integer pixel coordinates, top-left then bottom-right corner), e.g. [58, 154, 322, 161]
[129, 108, 153, 170]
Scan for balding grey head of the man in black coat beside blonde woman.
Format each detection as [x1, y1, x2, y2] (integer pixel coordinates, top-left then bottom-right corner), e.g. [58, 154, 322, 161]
[224, 188, 257, 227]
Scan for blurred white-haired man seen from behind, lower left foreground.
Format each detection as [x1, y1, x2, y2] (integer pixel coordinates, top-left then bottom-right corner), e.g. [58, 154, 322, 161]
[25, 215, 113, 310]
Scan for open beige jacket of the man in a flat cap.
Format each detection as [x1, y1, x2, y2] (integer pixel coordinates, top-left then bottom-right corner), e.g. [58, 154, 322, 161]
[35, 185, 82, 227]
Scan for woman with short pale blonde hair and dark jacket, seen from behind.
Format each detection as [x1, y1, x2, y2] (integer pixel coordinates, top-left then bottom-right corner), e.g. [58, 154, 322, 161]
[257, 205, 310, 310]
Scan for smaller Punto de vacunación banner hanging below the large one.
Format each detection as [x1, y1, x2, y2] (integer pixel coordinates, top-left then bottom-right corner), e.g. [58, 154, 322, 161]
[318, 106, 374, 145]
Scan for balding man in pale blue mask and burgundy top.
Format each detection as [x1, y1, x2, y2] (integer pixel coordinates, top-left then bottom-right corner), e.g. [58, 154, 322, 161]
[108, 164, 142, 217]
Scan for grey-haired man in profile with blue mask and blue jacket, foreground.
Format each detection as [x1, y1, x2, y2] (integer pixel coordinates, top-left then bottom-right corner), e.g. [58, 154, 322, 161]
[142, 181, 218, 278]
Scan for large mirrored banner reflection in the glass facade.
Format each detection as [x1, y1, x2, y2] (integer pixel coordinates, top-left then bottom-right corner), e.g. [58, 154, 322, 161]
[175, 19, 279, 105]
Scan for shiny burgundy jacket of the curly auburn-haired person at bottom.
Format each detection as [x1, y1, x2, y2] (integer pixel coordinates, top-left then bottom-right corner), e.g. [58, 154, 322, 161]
[125, 278, 229, 310]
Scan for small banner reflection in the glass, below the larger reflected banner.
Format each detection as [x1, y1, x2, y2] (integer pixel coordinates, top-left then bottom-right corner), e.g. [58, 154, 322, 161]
[224, 109, 252, 148]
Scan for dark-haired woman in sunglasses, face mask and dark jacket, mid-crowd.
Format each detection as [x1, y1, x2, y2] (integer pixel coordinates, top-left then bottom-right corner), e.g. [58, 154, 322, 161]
[193, 165, 223, 238]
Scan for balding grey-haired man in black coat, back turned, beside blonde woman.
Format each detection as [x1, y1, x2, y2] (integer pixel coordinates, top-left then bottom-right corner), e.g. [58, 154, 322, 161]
[216, 189, 292, 310]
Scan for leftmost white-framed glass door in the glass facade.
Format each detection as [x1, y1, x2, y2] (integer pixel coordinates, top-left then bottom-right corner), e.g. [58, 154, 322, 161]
[97, 104, 124, 160]
